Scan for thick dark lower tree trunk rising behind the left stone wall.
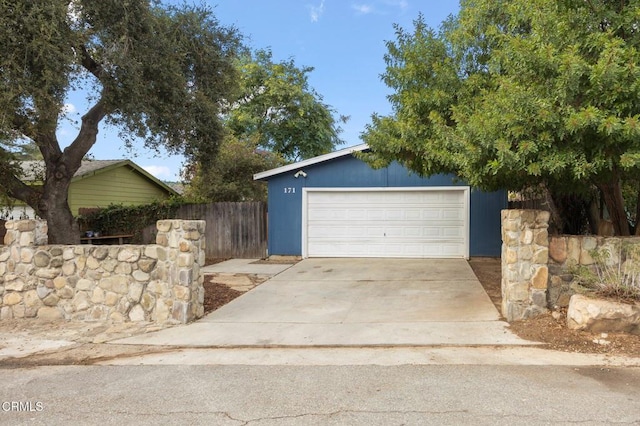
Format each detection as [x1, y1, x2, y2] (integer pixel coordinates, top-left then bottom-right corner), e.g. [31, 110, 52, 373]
[38, 162, 80, 244]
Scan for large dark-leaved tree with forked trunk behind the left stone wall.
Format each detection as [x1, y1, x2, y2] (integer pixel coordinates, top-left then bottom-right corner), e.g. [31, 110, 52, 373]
[0, 0, 242, 243]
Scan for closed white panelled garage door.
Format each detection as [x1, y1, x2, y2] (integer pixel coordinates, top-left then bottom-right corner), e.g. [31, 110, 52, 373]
[302, 187, 469, 258]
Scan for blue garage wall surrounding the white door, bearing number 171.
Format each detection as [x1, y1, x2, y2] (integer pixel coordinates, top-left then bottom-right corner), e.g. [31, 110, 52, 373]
[268, 155, 507, 256]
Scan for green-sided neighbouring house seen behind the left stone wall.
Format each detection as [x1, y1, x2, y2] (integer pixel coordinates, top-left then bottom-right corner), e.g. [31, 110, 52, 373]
[3, 160, 178, 219]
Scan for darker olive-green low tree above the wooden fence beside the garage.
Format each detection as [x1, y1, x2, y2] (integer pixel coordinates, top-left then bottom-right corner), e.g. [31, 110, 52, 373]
[185, 136, 285, 202]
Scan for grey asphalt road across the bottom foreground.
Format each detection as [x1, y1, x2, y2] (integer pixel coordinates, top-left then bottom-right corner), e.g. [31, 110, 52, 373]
[0, 365, 640, 426]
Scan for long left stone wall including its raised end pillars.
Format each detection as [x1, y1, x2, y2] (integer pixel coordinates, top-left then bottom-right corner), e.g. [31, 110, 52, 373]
[0, 220, 205, 323]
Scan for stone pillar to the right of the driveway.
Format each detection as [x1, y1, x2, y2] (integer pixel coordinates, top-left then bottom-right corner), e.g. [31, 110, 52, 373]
[502, 210, 549, 321]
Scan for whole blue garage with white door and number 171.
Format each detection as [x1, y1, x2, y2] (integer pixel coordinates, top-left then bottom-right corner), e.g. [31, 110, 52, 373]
[254, 144, 507, 258]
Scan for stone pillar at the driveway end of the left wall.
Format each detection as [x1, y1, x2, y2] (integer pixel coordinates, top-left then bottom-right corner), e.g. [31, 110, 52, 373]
[155, 220, 205, 323]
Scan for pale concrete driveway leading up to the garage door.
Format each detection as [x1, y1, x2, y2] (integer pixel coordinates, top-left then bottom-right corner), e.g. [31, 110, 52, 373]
[113, 259, 531, 347]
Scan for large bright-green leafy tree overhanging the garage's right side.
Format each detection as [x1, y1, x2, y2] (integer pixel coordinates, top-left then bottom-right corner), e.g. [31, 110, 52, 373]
[363, 0, 640, 235]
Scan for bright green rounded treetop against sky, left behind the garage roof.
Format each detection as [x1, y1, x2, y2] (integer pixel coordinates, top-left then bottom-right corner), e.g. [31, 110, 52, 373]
[226, 50, 348, 161]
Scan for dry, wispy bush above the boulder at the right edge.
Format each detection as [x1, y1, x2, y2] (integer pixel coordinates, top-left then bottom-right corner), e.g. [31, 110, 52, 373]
[571, 242, 640, 301]
